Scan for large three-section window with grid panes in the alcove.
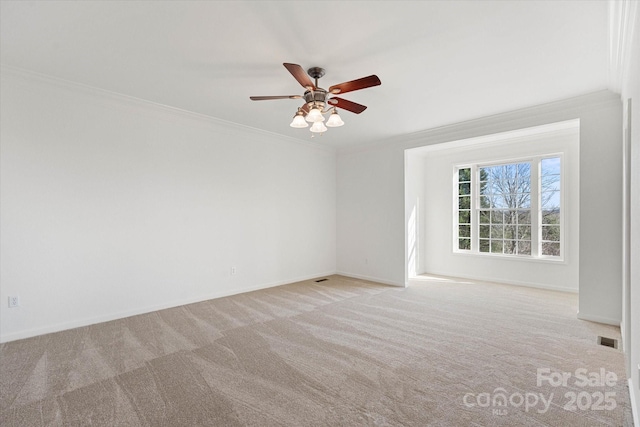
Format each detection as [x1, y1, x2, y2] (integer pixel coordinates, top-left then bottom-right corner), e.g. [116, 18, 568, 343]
[455, 155, 562, 259]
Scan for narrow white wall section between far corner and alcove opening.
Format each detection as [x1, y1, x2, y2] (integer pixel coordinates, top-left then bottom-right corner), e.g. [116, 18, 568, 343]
[337, 148, 406, 286]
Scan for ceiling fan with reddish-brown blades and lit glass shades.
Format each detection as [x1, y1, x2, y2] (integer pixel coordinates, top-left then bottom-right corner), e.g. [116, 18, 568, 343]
[249, 62, 382, 134]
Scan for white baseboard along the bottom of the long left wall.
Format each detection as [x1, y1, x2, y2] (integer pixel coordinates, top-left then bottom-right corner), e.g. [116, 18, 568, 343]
[0, 271, 336, 343]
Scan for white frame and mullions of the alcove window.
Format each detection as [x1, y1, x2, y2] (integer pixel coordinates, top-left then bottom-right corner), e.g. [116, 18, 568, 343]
[451, 152, 567, 263]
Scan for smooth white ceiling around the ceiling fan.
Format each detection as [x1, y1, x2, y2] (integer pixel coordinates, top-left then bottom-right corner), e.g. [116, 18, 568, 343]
[0, 0, 609, 148]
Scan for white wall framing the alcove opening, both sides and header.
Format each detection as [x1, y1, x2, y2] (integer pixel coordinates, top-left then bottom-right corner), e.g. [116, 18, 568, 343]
[337, 91, 622, 324]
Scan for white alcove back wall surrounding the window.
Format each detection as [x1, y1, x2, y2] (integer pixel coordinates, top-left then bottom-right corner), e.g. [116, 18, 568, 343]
[407, 121, 580, 292]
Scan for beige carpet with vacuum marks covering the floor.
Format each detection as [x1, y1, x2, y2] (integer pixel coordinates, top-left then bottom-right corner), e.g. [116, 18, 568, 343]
[0, 276, 632, 427]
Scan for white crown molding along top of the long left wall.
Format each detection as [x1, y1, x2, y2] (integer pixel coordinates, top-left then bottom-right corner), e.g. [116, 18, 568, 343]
[0, 64, 336, 153]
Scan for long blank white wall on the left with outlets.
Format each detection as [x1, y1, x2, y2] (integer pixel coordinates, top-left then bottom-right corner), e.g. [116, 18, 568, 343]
[0, 68, 336, 341]
